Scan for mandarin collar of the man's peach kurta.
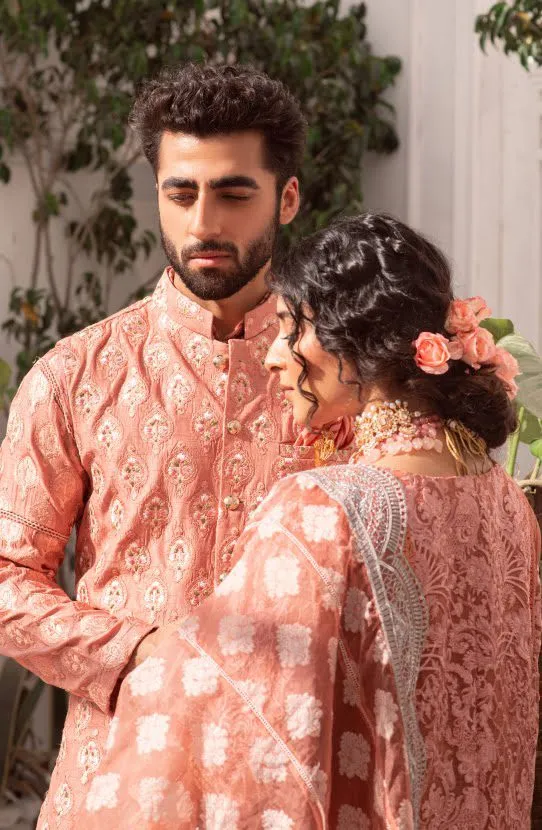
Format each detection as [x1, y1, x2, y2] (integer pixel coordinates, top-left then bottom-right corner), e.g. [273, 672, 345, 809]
[151, 268, 277, 340]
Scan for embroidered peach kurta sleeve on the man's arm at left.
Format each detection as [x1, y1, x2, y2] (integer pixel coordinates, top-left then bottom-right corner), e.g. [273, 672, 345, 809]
[0, 356, 152, 712]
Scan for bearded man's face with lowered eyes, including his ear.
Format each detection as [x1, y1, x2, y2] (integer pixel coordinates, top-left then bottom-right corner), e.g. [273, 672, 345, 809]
[157, 132, 298, 301]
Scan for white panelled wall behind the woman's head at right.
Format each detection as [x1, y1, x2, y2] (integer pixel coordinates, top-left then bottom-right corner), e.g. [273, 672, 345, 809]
[364, 0, 542, 348]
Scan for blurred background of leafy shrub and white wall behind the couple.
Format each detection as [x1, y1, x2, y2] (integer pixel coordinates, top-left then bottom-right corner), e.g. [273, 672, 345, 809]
[0, 0, 542, 828]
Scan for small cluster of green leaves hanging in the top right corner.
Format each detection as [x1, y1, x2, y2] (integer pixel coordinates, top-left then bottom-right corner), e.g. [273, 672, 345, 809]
[475, 0, 542, 69]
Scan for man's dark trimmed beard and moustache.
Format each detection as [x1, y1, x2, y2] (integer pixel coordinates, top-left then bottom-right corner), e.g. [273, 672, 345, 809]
[160, 211, 280, 300]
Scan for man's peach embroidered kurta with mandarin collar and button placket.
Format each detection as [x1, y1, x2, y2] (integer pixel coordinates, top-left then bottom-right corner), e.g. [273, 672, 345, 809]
[0, 272, 348, 827]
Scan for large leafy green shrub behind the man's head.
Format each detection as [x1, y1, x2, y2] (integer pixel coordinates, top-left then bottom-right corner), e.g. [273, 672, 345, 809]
[0, 0, 400, 380]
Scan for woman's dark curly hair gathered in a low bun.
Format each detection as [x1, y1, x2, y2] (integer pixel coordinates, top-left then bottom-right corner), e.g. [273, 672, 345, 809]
[270, 213, 516, 449]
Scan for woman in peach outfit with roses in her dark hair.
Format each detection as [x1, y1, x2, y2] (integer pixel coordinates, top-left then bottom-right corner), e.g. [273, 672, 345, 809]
[75, 214, 540, 830]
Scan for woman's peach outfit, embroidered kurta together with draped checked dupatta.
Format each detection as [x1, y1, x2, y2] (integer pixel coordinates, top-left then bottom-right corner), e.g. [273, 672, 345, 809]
[73, 465, 540, 830]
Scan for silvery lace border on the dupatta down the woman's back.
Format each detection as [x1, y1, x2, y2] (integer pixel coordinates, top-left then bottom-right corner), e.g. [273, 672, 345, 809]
[303, 465, 428, 828]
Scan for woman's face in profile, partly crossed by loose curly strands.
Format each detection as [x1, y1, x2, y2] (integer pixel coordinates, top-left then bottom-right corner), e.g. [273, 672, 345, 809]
[266, 297, 363, 428]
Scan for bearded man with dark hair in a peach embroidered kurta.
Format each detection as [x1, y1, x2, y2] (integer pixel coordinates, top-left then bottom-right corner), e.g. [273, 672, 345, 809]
[0, 65, 350, 830]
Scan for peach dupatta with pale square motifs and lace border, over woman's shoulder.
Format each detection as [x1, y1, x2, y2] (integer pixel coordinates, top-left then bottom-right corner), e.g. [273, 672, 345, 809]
[74, 466, 427, 830]
